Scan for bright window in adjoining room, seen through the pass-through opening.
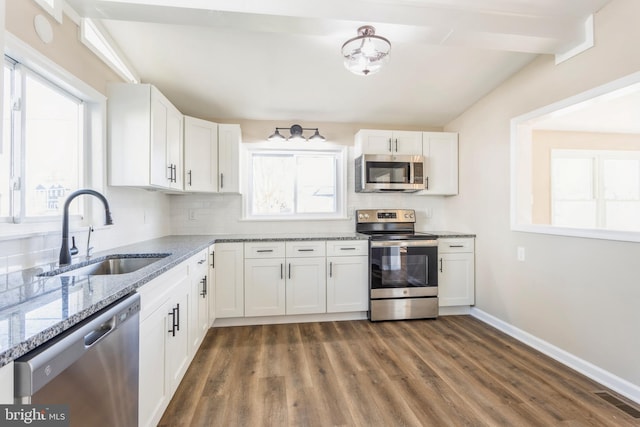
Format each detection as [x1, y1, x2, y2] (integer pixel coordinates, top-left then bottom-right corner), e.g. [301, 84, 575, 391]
[551, 149, 640, 231]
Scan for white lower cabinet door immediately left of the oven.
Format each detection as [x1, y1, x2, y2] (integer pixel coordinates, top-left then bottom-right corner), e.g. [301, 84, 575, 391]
[327, 256, 369, 313]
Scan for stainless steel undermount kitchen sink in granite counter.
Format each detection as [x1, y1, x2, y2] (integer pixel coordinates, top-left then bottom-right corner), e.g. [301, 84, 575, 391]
[40, 254, 170, 277]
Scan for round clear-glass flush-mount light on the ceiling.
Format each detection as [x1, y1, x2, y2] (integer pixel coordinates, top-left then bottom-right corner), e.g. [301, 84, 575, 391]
[342, 25, 391, 76]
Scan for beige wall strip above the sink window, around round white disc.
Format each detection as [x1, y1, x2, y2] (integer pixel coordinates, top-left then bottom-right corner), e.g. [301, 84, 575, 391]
[5, 0, 122, 94]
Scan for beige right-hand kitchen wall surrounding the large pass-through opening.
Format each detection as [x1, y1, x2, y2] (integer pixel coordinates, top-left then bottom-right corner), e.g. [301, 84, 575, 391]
[445, 0, 640, 394]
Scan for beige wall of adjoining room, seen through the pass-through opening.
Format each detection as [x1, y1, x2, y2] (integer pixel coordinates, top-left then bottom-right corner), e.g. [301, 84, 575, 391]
[531, 130, 640, 224]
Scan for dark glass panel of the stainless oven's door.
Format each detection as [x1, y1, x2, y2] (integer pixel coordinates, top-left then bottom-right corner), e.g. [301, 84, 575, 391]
[371, 247, 438, 289]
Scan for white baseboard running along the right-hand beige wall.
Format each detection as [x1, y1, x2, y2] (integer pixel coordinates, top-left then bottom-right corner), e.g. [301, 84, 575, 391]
[470, 307, 640, 403]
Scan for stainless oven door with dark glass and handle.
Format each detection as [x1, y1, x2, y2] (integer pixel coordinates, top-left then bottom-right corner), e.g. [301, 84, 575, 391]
[370, 240, 438, 299]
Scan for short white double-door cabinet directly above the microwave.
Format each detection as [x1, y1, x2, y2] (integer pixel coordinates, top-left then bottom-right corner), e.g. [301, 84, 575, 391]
[355, 129, 422, 157]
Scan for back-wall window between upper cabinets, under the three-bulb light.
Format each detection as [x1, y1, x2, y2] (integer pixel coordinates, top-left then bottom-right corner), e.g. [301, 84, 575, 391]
[245, 143, 346, 219]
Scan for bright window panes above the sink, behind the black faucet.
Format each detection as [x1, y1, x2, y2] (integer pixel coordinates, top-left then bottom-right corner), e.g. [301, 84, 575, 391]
[0, 57, 86, 223]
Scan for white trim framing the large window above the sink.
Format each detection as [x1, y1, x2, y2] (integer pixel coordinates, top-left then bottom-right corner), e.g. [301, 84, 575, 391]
[0, 33, 107, 240]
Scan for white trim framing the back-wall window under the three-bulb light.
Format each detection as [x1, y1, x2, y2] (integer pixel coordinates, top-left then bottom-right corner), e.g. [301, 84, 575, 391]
[241, 142, 348, 221]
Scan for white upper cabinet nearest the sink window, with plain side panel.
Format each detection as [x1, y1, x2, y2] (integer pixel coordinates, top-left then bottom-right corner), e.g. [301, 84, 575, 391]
[108, 83, 183, 191]
